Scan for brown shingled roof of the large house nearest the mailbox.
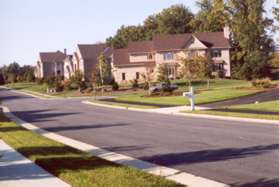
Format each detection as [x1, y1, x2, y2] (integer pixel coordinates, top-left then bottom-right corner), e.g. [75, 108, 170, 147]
[113, 32, 230, 66]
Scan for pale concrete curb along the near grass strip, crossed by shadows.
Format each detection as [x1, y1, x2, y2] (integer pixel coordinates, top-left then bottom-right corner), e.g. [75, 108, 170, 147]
[1, 106, 229, 187]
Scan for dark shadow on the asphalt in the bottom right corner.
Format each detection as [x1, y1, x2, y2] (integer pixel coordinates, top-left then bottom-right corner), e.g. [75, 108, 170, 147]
[231, 178, 279, 187]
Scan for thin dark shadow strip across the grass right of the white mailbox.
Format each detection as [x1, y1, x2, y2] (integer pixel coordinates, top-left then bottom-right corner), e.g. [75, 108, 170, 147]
[208, 108, 279, 115]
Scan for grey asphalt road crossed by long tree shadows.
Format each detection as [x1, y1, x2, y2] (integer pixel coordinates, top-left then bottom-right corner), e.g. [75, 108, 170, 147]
[0, 89, 279, 187]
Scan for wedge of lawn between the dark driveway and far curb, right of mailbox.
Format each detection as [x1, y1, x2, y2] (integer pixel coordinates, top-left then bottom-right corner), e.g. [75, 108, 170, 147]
[190, 100, 279, 120]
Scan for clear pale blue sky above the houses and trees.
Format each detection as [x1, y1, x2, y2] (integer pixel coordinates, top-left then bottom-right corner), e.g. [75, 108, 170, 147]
[0, 0, 279, 66]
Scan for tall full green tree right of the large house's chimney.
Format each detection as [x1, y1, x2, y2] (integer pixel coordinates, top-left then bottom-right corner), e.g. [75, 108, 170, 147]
[229, 0, 273, 79]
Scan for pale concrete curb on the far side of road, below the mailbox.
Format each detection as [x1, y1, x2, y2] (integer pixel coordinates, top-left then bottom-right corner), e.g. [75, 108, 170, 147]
[82, 101, 279, 125]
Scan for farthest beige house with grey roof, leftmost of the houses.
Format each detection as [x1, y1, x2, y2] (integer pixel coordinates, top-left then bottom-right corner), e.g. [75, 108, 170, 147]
[35, 50, 67, 78]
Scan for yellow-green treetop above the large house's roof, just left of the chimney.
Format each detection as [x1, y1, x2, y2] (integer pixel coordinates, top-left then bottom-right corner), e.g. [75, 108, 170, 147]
[191, 0, 229, 32]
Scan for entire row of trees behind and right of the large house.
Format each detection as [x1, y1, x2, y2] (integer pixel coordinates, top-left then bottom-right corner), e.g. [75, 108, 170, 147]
[107, 0, 279, 80]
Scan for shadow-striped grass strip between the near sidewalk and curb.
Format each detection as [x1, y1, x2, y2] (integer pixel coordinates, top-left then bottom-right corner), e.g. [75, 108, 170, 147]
[0, 113, 182, 187]
